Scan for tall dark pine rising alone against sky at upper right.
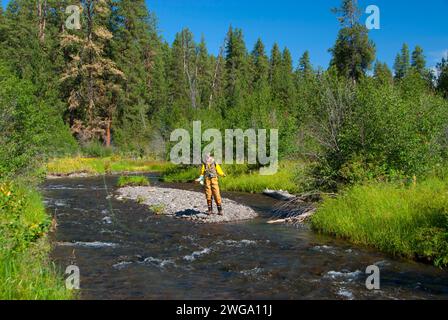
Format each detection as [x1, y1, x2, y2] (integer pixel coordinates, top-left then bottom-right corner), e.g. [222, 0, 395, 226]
[330, 0, 376, 81]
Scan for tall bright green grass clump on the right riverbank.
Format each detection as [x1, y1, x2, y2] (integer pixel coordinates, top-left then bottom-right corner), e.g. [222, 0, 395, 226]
[312, 178, 448, 266]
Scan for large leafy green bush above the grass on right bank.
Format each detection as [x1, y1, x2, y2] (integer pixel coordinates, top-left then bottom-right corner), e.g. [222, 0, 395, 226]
[310, 73, 448, 189]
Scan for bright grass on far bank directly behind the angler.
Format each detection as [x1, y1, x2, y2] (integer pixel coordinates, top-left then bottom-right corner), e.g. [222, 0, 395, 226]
[162, 161, 304, 193]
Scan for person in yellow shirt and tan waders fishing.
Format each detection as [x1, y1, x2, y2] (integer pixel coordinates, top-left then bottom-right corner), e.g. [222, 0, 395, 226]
[197, 154, 226, 216]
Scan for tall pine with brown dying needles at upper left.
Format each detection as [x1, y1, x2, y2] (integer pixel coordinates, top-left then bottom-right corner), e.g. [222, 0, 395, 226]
[61, 0, 125, 146]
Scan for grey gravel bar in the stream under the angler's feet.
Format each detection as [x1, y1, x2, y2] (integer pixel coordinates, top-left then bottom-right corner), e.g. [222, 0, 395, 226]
[116, 187, 258, 223]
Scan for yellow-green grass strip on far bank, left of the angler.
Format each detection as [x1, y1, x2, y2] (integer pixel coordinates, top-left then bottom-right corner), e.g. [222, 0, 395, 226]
[46, 156, 172, 176]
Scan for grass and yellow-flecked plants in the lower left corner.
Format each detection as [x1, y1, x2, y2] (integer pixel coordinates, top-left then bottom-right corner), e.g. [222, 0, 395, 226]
[0, 183, 72, 300]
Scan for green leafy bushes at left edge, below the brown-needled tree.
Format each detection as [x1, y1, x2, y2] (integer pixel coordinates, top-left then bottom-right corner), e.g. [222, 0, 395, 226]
[0, 63, 76, 178]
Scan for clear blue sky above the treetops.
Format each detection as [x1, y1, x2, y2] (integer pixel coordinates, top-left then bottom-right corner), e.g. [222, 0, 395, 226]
[1, 0, 448, 67]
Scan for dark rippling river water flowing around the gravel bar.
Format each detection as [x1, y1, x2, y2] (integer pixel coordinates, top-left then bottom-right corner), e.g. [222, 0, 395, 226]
[42, 176, 448, 299]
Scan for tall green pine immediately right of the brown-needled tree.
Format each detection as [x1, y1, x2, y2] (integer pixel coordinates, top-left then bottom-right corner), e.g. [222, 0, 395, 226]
[110, 0, 159, 152]
